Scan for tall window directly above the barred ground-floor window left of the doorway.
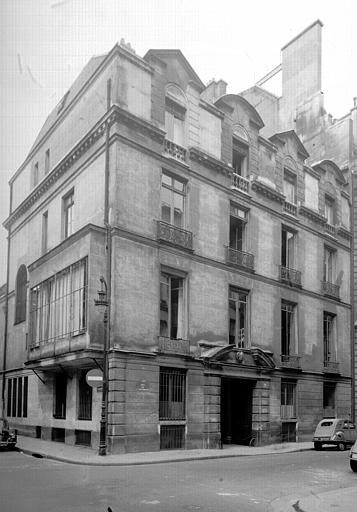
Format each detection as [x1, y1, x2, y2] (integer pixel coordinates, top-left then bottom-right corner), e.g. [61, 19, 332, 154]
[160, 273, 185, 339]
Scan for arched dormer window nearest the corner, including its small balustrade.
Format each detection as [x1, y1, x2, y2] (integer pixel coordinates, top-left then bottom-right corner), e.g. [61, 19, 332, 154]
[164, 85, 187, 162]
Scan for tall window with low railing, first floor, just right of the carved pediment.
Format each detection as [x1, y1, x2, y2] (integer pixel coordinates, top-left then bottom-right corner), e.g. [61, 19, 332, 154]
[281, 301, 298, 366]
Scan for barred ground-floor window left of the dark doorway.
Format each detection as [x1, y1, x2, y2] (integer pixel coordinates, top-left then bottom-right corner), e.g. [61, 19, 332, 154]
[159, 368, 186, 420]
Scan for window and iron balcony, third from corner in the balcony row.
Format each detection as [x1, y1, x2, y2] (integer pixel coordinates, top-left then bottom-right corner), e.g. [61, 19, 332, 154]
[280, 227, 301, 288]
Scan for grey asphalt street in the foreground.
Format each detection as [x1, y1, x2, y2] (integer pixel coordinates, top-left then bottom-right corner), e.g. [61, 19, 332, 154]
[0, 448, 357, 512]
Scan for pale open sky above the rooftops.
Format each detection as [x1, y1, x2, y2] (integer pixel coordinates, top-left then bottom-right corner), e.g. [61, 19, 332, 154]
[0, 0, 357, 286]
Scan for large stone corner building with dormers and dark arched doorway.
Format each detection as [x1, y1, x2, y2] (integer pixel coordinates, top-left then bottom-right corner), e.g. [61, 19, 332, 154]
[0, 35, 351, 453]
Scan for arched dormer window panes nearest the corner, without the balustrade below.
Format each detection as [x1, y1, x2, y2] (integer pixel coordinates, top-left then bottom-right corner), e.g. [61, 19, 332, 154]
[165, 84, 186, 147]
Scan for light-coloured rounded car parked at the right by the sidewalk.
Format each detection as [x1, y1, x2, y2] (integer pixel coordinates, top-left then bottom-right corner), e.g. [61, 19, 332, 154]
[312, 418, 357, 450]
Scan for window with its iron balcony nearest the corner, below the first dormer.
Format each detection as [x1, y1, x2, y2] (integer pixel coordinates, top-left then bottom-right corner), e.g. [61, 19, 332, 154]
[157, 172, 193, 251]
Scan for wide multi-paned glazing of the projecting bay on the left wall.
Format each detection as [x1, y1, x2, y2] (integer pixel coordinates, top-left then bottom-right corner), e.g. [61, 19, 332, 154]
[30, 259, 87, 346]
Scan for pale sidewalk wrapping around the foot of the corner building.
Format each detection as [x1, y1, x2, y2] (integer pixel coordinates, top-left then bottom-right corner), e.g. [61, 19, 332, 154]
[17, 436, 313, 466]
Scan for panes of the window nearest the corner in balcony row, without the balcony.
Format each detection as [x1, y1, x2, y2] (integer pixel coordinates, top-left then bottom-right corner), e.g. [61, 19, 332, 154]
[161, 173, 185, 228]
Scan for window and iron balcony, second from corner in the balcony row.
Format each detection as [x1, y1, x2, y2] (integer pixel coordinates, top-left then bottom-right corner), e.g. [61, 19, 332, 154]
[226, 203, 254, 272]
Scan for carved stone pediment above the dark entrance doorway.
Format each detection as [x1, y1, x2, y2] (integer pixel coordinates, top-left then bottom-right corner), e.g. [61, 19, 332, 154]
[199, 343, 276, 370]
